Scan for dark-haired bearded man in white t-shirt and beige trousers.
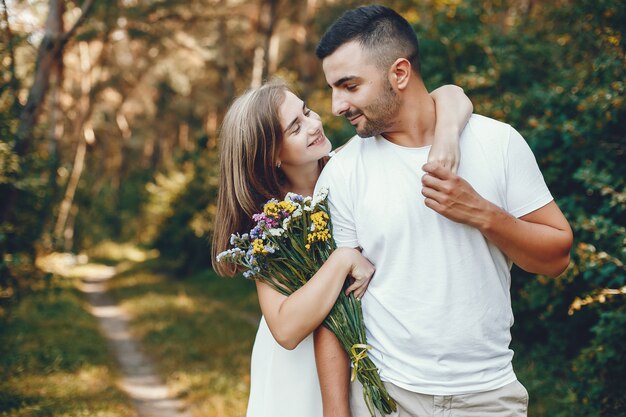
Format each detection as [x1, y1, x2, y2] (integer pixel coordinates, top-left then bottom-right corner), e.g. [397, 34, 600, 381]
[316, 6, 572, 417]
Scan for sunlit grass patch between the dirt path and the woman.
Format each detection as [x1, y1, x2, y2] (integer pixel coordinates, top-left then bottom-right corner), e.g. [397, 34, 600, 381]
[110, 261, 260, 417]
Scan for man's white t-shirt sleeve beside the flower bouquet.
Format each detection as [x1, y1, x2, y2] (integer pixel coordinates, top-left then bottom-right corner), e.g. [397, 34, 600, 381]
[315, 161, 359, 248]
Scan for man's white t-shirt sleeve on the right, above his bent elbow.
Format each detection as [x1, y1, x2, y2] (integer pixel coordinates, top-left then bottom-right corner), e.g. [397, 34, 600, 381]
[506, 127, 553, 217]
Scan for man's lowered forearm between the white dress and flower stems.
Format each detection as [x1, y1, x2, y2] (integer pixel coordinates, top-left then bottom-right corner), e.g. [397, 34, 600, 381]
[314, 326, 350, 417]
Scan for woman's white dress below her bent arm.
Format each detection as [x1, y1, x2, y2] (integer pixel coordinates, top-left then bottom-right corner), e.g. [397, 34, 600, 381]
[246, 317, 322, 417]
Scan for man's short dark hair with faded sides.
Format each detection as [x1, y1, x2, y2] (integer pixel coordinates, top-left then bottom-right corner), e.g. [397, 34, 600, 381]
[315, 5, 420, 74]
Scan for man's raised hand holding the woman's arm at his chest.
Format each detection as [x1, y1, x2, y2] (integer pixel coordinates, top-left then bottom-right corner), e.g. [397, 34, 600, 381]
[422, 162, 492, 229]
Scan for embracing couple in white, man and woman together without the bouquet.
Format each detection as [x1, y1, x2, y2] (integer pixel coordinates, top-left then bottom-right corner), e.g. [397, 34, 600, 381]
[213, 6, 572, 417]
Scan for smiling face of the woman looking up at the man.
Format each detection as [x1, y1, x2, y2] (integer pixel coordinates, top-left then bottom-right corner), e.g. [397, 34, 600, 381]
[278, 91, 332, 166]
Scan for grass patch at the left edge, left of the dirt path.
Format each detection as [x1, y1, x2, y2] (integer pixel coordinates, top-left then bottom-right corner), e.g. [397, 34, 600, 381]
[0, 275, 136, 417]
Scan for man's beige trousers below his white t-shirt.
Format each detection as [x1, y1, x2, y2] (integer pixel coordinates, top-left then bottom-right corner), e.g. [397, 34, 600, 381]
[350, 379, 528, 417]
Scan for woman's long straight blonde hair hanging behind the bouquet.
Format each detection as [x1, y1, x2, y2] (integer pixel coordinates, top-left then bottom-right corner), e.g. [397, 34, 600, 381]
[211, 80, 290, 276]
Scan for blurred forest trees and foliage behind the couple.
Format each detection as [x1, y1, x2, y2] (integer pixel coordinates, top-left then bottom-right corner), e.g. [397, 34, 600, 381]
[0, 0, 626, 417]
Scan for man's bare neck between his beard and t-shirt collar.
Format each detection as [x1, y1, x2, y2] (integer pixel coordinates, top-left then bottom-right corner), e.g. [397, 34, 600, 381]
[382, 82, 437, 148]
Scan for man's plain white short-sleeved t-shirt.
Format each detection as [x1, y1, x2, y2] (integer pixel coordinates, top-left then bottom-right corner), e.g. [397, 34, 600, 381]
[316, 115, 552, 395]
